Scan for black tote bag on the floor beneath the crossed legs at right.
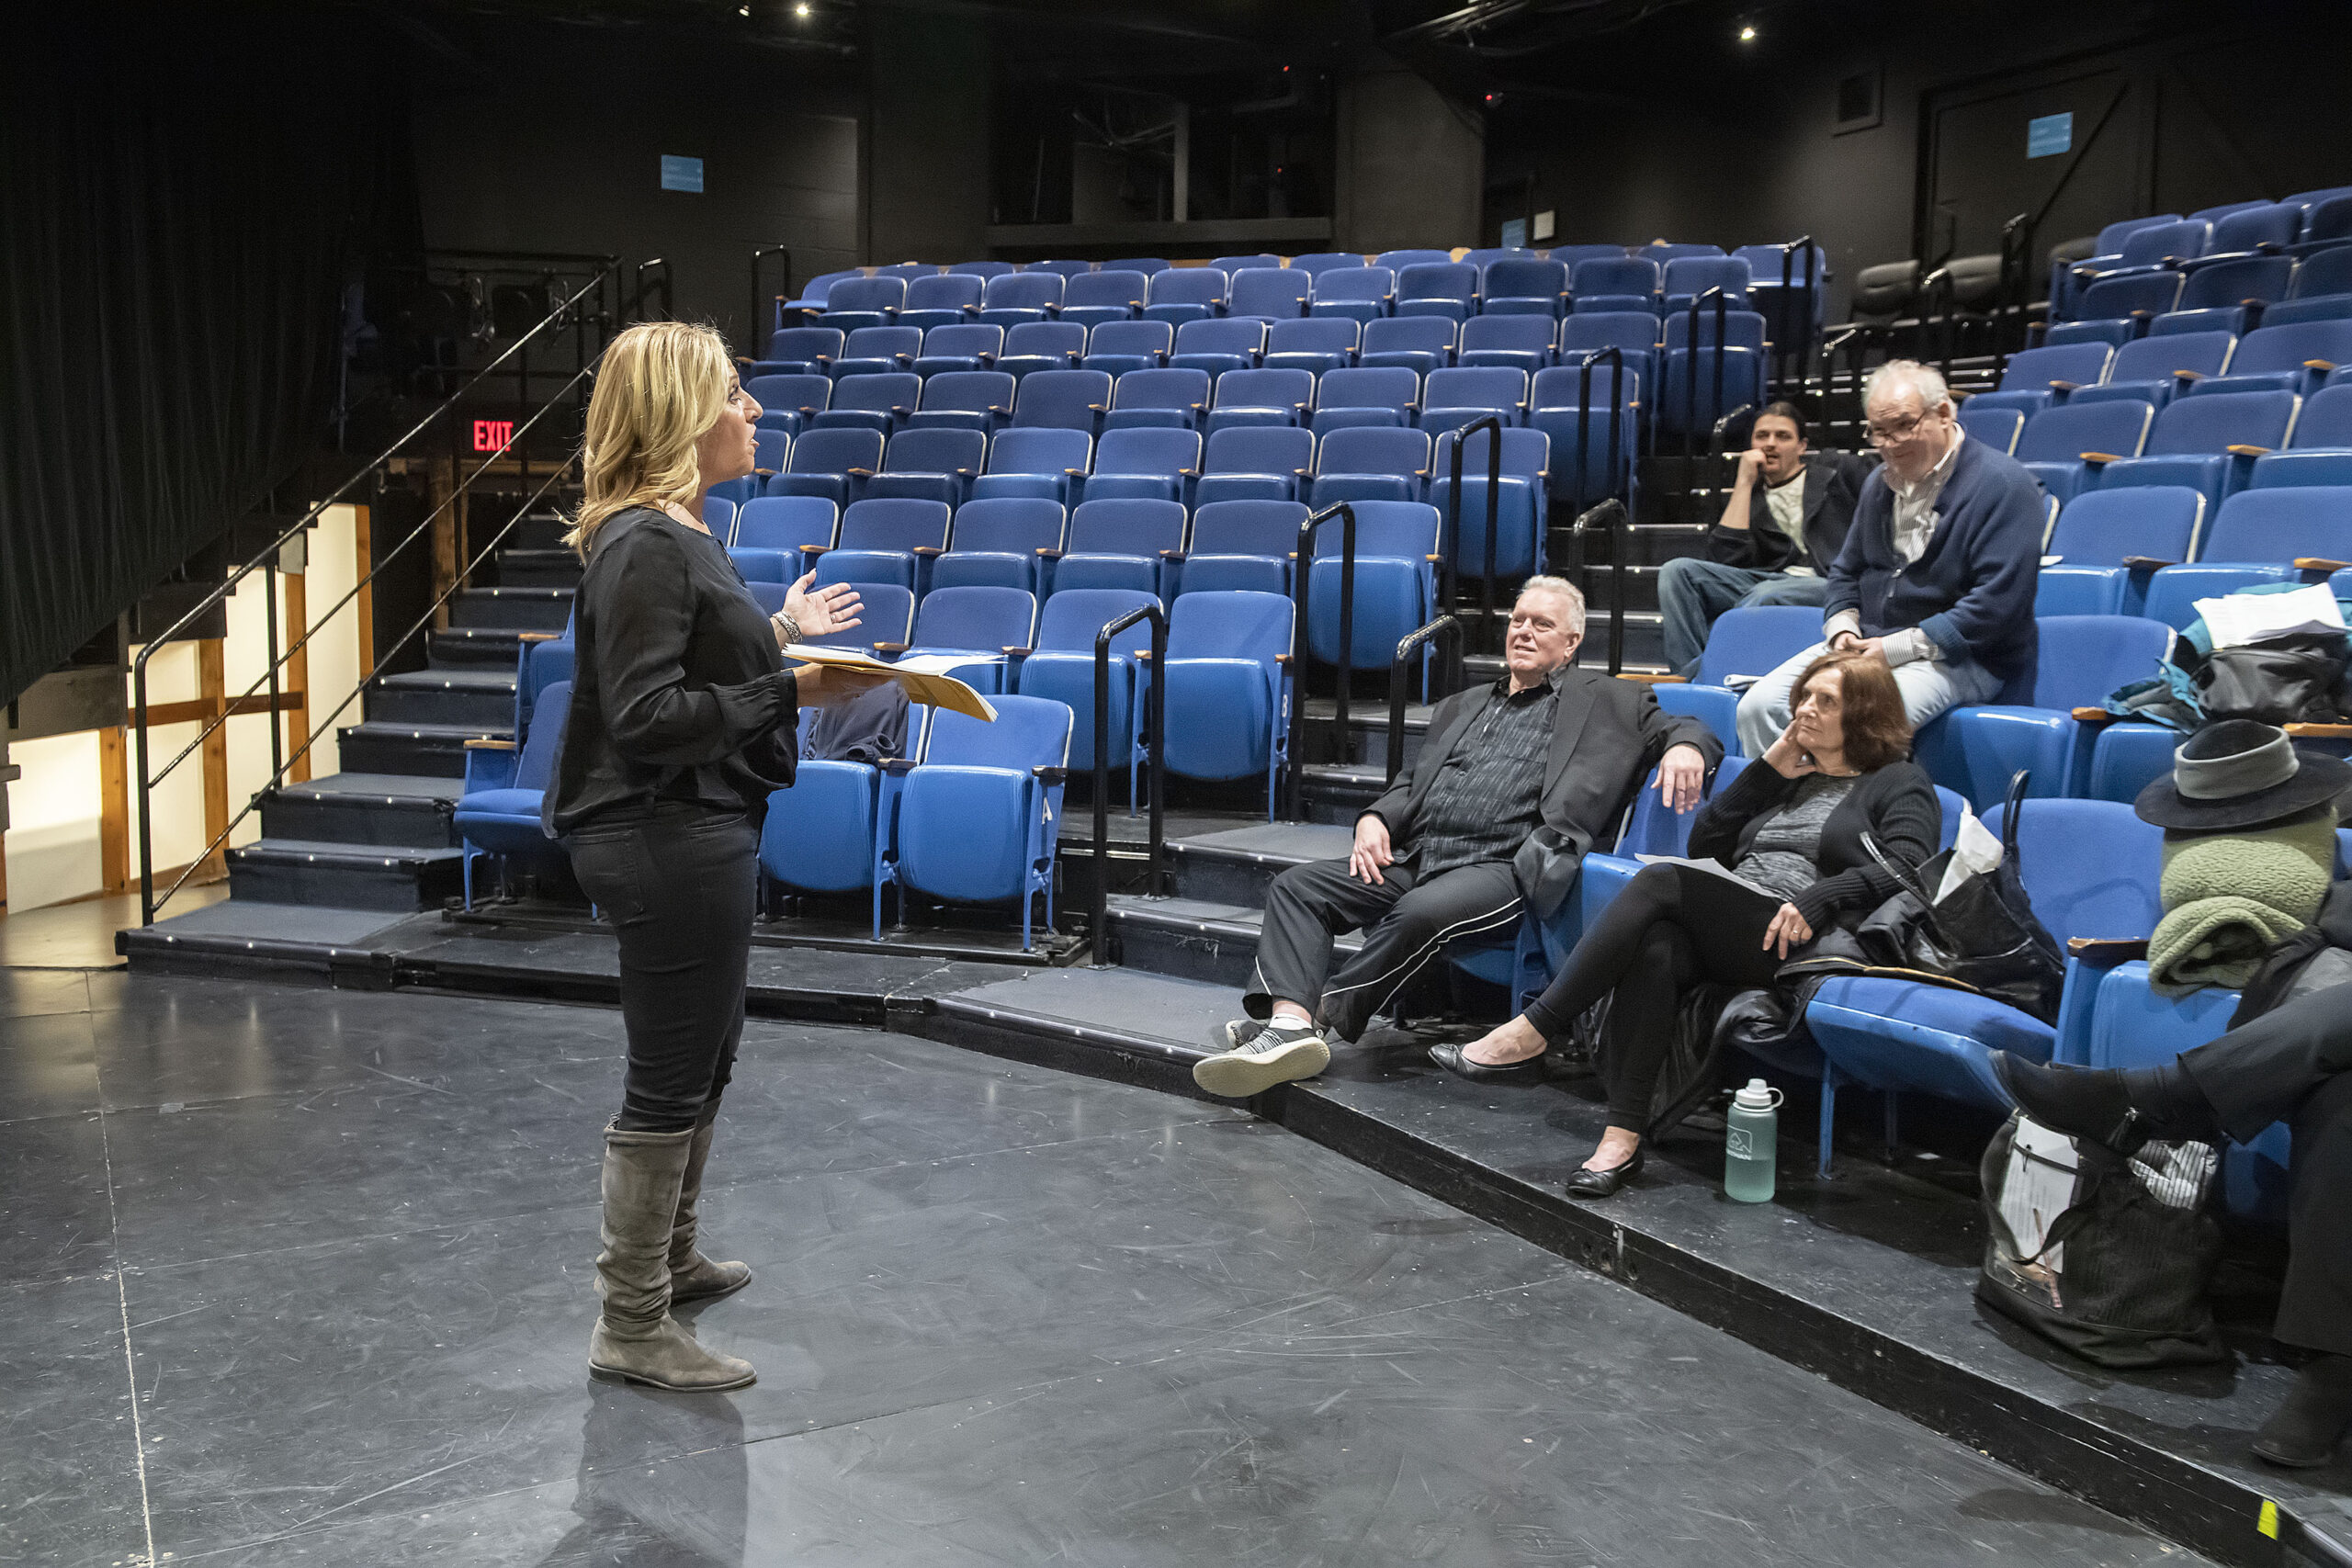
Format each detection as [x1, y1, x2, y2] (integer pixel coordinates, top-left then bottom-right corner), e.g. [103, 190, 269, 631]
[1975, 1112, 2230, 1368]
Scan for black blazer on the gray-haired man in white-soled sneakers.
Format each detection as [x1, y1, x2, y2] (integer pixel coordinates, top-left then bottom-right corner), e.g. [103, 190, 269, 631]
[1366, 665, 1731, 919]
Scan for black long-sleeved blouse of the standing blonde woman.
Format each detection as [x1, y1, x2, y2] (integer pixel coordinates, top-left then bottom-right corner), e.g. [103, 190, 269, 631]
[543, 508, 799, 835]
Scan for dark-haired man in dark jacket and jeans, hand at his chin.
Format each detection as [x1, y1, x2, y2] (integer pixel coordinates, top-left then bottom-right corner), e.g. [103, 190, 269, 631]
[1658, 402, 1870, 674]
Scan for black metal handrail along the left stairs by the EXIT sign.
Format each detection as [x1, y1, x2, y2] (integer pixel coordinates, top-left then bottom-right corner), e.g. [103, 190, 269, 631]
[131, 259, 621, 926]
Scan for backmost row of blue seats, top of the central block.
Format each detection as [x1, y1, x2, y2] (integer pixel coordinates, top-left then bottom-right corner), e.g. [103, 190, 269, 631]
[790, 256, 1815, 332]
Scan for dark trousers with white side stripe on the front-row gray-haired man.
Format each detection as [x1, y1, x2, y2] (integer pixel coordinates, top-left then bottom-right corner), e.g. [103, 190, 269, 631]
[1242, 861, 1520, 1039]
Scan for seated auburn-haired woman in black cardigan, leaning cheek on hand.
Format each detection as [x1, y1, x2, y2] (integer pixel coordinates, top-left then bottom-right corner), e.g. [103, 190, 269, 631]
[1430, 653, 1943, 1197]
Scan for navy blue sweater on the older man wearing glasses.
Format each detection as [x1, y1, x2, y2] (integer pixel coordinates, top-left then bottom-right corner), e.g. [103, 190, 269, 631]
[1820, 434, 2044, 682]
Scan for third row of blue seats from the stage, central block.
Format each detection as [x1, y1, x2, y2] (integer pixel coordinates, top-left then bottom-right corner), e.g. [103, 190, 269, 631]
[729, 496, 1476, 670]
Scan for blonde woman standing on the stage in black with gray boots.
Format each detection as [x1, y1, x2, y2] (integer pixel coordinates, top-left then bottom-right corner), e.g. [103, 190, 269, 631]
[546, 322, 875, 1389]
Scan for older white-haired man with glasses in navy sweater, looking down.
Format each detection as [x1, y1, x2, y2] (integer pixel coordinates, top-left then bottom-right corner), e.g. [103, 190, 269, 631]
[1738, 360, 2044, 757]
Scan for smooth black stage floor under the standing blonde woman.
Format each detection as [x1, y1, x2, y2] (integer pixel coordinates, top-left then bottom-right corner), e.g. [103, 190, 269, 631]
[0, 971, 2239, 1568]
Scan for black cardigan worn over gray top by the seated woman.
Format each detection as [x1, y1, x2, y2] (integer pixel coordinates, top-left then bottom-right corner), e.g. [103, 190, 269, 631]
[1691, 760, 1943, 931]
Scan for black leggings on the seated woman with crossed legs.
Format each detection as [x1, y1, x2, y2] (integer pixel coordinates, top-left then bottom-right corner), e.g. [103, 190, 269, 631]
[1526, 865, 1781, 1134]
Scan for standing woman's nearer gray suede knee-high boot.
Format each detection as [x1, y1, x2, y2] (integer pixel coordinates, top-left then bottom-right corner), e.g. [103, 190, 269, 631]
[588, 1126, 755, 1392]
